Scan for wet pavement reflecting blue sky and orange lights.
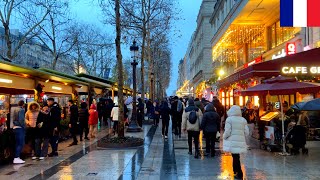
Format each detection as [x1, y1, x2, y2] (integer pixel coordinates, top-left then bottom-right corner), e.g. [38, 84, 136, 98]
[0, 120, 320, 180]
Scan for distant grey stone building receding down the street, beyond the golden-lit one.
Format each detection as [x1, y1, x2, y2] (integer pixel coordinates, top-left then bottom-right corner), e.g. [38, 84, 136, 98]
[178, 0, 216, 97]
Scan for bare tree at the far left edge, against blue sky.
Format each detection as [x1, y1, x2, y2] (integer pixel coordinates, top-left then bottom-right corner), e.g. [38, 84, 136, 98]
[0, 0, 55, 60]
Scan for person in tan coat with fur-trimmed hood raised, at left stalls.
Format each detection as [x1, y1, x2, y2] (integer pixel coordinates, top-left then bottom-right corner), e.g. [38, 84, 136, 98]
[25, 102, 40, 160]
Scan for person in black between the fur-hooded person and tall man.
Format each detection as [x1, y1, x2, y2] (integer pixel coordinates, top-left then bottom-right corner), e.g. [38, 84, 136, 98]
[35, 105, 50, 160]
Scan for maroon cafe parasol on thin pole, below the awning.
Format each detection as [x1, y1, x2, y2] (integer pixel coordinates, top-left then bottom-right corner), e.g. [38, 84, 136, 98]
[241, 76, 320, 155]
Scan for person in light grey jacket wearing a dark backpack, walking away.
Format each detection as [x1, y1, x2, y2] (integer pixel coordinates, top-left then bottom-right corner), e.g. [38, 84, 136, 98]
[182, 99, 202, 158]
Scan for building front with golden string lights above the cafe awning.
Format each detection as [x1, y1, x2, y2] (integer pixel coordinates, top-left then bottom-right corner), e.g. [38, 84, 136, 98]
[210, 0, 320, 108]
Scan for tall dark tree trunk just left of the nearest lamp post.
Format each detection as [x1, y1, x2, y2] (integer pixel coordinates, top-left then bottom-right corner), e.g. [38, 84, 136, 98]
[115, 0, 124, 137]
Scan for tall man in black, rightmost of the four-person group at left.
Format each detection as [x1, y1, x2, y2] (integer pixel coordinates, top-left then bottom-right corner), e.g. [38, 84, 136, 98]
[47, 98, 61, 157]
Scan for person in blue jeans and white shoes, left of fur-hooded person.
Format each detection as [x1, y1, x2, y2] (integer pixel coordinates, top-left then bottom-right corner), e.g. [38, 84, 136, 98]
[10, 100, 26, 164]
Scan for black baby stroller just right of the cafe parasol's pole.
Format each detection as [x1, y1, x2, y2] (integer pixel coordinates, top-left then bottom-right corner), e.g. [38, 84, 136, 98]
[286, 125, 309, 155]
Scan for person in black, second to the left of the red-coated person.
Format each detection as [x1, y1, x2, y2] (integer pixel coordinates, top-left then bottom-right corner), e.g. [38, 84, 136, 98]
[68, 100, 79, 146]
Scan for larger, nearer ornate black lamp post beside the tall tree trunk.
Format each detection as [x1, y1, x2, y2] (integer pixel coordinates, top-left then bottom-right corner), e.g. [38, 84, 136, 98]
[127, 40, 142, 132]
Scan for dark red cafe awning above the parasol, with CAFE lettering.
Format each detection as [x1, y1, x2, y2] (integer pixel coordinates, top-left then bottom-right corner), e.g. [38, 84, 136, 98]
[218, 48, 320, 88]
